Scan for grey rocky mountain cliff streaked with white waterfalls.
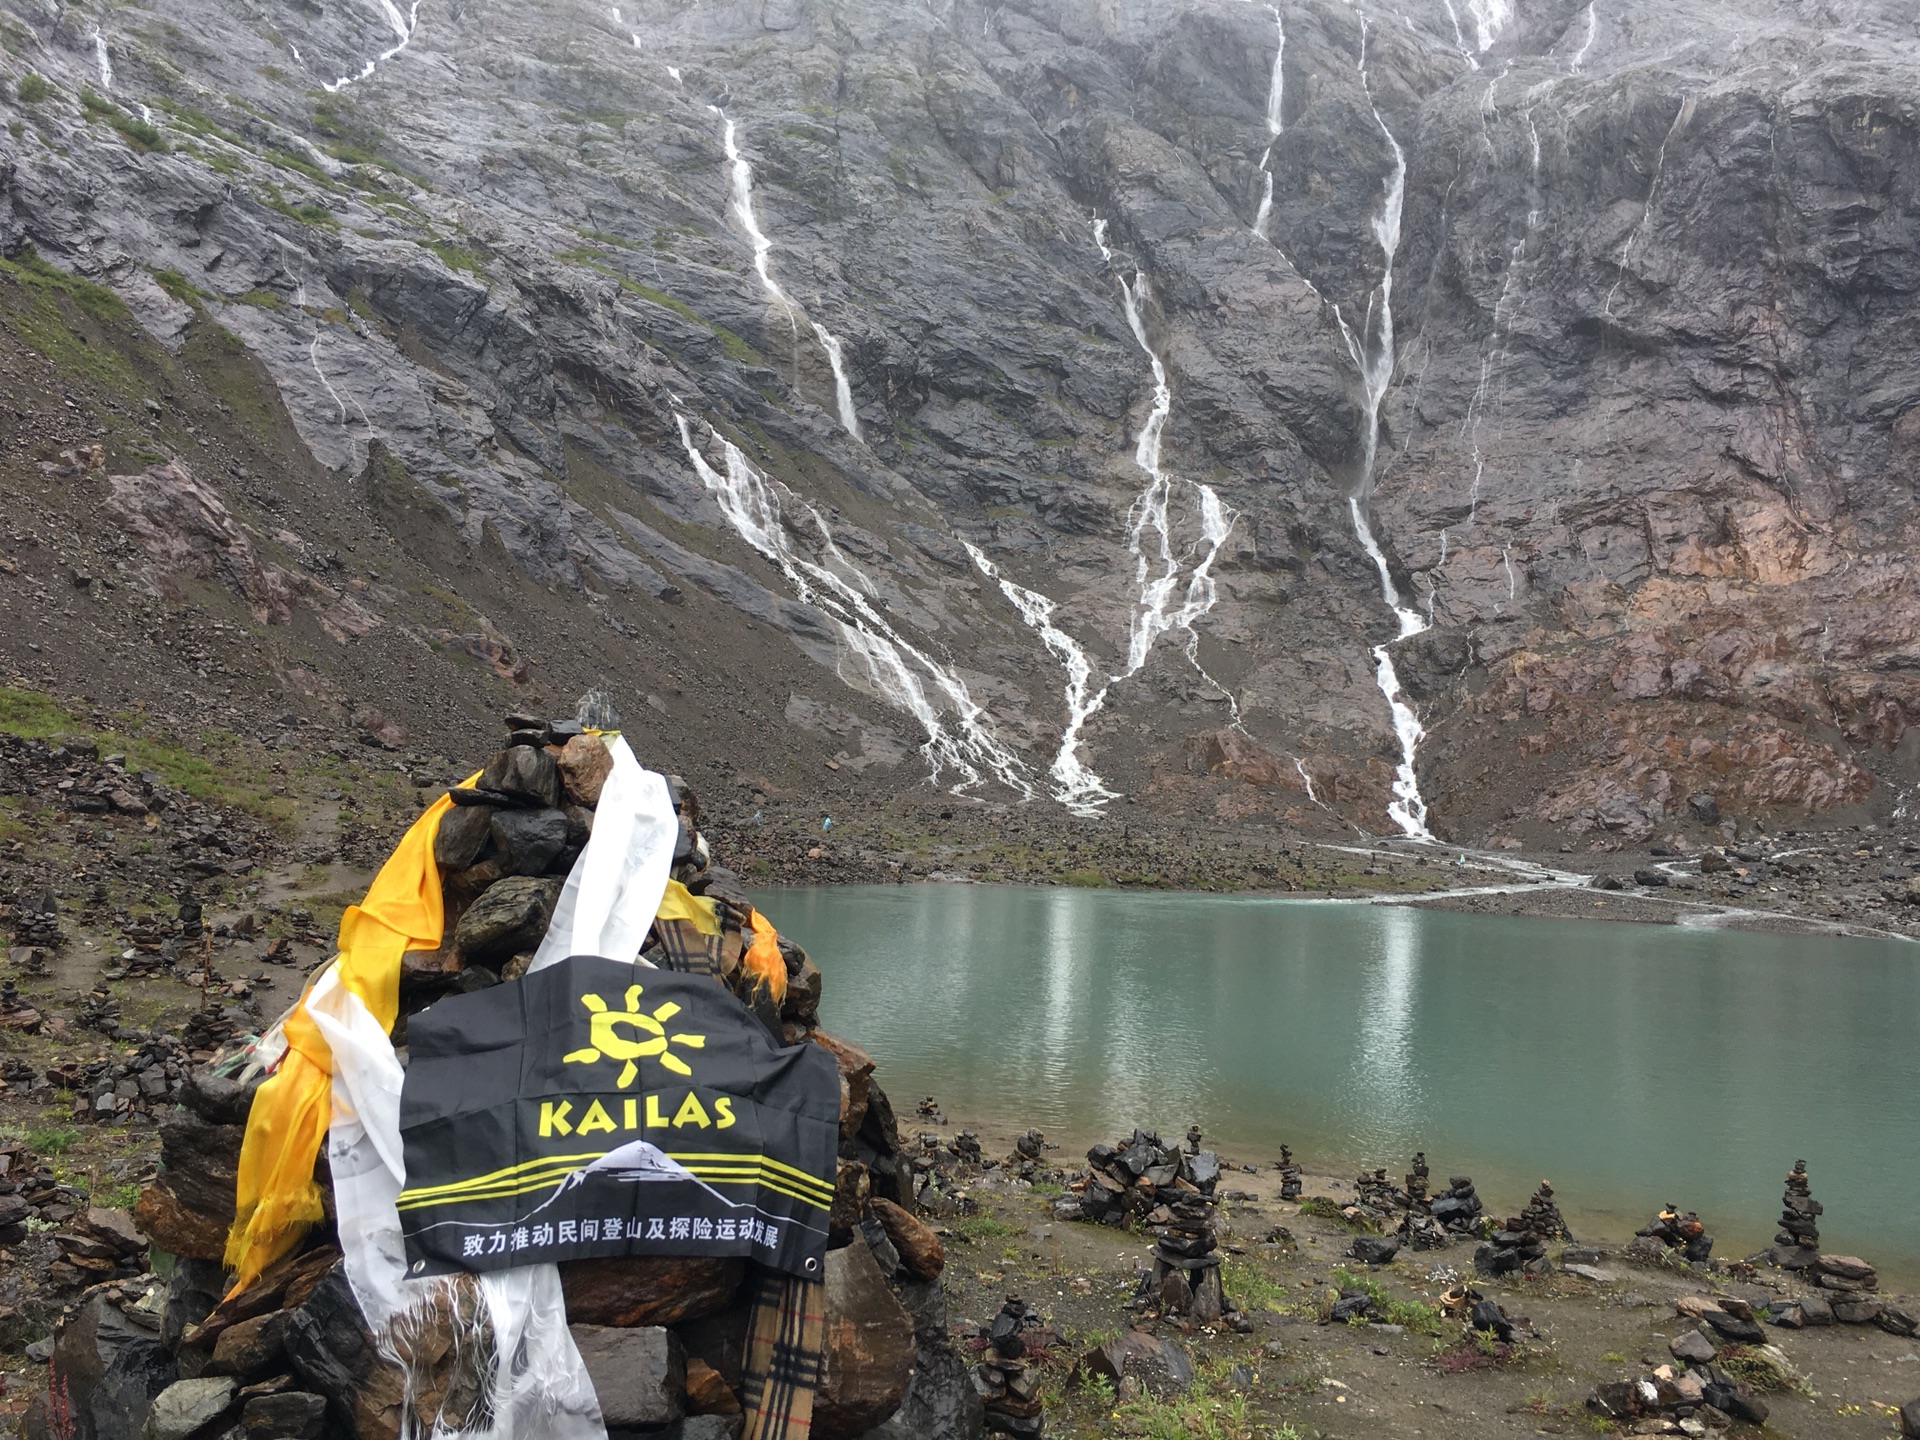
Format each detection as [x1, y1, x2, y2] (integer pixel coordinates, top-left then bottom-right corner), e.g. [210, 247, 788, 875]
[0, 0, 1920, 847]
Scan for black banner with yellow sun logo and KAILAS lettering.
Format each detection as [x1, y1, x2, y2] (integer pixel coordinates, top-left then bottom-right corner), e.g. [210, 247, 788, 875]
[399, 956, 839, 1277]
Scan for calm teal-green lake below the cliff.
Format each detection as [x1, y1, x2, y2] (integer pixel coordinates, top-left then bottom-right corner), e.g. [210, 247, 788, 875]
[760, 885, 1920, 1284]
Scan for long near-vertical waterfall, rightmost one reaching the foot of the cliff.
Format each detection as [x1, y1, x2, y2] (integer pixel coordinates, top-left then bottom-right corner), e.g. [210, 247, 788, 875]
[1334, 19, 1432, 839]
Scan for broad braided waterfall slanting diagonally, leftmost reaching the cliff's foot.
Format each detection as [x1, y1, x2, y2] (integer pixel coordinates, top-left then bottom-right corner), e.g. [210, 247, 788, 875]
[674, 403, 1035, 801]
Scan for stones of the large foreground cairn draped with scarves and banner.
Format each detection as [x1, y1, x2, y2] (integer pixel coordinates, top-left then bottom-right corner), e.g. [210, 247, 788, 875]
[30, 716, 983, 1440]
